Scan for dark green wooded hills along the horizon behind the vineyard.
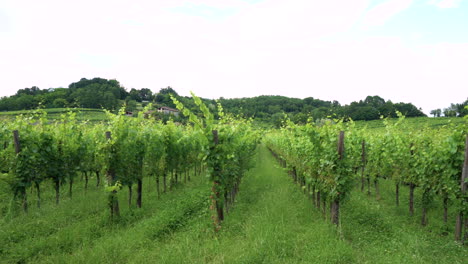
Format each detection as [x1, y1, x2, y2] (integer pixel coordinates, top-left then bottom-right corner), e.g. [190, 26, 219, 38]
[0, 78, 468, 126]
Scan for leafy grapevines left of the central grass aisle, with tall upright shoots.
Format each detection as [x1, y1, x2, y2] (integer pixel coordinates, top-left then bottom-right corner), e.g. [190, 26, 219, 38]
[0, 97, 257, 229]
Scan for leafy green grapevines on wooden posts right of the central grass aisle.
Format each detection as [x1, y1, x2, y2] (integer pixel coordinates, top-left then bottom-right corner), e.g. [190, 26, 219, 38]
[266, 114, 468, 240]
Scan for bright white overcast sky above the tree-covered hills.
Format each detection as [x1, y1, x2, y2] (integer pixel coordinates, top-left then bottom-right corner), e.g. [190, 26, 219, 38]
[0, 0, 468, 114]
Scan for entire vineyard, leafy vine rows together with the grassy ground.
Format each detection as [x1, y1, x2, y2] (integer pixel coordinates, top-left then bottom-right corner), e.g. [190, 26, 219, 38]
[0, 96, 468, 263]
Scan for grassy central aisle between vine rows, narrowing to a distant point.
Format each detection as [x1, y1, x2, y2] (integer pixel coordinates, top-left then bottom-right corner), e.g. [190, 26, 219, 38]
[120, 148, 355, 263]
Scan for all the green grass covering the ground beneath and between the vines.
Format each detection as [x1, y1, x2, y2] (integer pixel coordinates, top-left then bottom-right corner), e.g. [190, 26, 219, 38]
[0, 146, 468, 264]
